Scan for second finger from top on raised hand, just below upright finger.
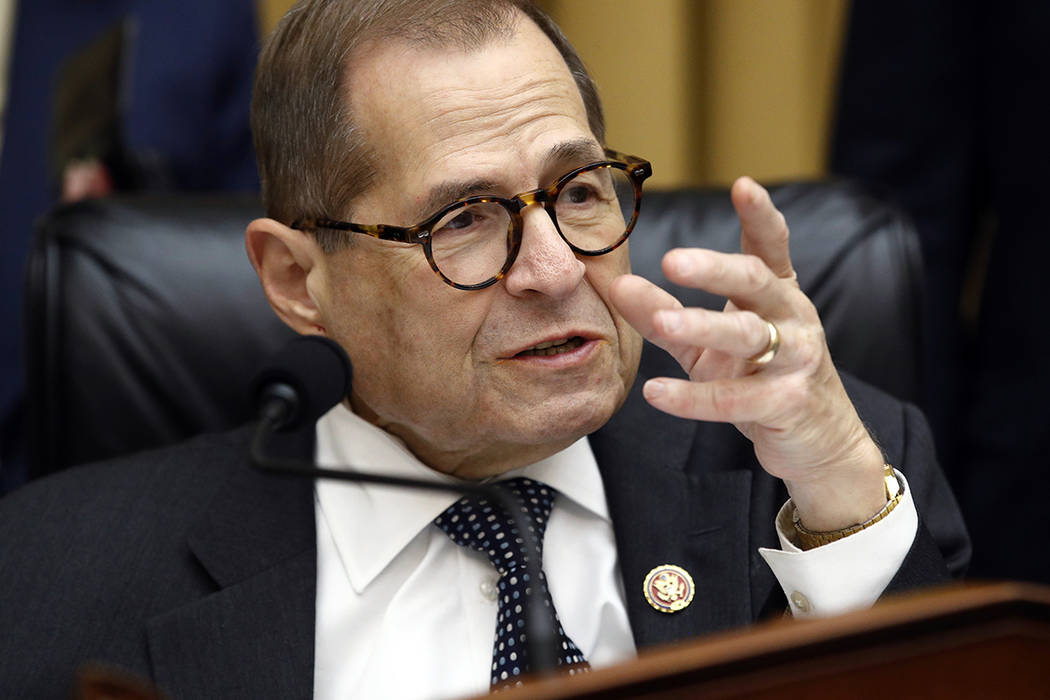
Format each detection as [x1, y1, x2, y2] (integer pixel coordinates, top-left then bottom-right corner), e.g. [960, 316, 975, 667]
[663, 248, 794, 318]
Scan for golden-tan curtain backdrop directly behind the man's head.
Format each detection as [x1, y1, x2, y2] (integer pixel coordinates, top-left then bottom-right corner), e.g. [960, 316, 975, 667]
[259, 0, 847, 187]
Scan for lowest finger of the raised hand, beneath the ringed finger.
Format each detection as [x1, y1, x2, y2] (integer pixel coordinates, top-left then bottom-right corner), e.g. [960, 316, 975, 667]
[642, 374, 779, 424]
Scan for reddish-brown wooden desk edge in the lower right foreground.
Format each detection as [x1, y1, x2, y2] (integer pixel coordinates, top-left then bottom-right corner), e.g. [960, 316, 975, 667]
[480, 584, 1050, 700]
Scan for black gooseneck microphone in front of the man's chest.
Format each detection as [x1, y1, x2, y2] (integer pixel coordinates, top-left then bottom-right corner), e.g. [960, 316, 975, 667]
[249, 336, 558, 676]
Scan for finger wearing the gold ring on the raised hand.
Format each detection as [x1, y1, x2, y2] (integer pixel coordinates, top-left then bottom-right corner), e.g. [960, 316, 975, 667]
[653, 309, 771, 359]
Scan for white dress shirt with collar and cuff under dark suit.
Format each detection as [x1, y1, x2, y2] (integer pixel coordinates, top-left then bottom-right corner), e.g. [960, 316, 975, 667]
[314, 405, 915, 699]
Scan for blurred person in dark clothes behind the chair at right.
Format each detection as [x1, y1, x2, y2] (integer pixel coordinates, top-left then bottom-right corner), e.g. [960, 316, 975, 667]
[832, 0, 1050, 582]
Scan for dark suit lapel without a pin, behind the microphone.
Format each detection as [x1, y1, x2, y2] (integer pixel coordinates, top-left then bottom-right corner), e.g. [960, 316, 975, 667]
[147, 429, 317, 698]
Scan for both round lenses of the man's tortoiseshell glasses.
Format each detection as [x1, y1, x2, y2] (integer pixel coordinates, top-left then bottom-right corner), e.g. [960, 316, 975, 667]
[431, 166, 635, 285]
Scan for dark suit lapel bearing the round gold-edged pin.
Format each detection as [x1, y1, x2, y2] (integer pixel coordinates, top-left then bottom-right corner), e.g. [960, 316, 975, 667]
[591, 371, 757, 649]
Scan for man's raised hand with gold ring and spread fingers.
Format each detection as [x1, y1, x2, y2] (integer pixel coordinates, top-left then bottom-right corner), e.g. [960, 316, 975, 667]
[610, 177, 886, 531]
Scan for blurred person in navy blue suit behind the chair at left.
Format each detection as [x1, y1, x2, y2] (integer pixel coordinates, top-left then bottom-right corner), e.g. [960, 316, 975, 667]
[0, 0, 259, 493]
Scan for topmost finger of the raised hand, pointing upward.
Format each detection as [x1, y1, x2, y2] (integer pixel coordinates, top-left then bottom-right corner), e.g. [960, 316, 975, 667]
[730, 177, 795, 277]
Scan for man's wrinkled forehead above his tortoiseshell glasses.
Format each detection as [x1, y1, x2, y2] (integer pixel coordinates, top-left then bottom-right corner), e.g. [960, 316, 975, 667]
[348, 18, 601, 214]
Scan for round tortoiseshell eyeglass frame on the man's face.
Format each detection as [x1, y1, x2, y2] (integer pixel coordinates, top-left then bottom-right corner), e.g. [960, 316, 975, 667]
[292, 148, 653, 291]
